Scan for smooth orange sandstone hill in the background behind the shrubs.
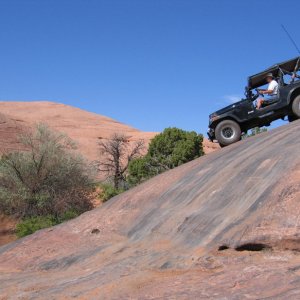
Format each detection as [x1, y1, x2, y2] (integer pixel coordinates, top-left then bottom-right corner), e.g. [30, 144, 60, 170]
[0, 101, 218, 160]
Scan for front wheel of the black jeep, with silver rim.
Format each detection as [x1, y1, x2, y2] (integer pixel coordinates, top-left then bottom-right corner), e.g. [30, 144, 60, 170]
[215, 120, 241, 147]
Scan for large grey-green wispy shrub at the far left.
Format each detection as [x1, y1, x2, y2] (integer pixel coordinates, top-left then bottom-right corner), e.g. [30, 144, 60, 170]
[0, 124, 94, 219]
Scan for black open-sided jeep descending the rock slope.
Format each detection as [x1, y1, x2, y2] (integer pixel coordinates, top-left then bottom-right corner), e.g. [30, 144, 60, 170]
[207, 57, 300, 147]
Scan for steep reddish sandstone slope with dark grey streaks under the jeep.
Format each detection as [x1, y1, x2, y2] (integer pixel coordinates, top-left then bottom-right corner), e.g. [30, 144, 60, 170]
[0, 121, 300, 299]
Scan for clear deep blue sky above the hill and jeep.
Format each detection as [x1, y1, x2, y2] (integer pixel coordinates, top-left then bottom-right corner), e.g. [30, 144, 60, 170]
[0, 0, 300, 133]
